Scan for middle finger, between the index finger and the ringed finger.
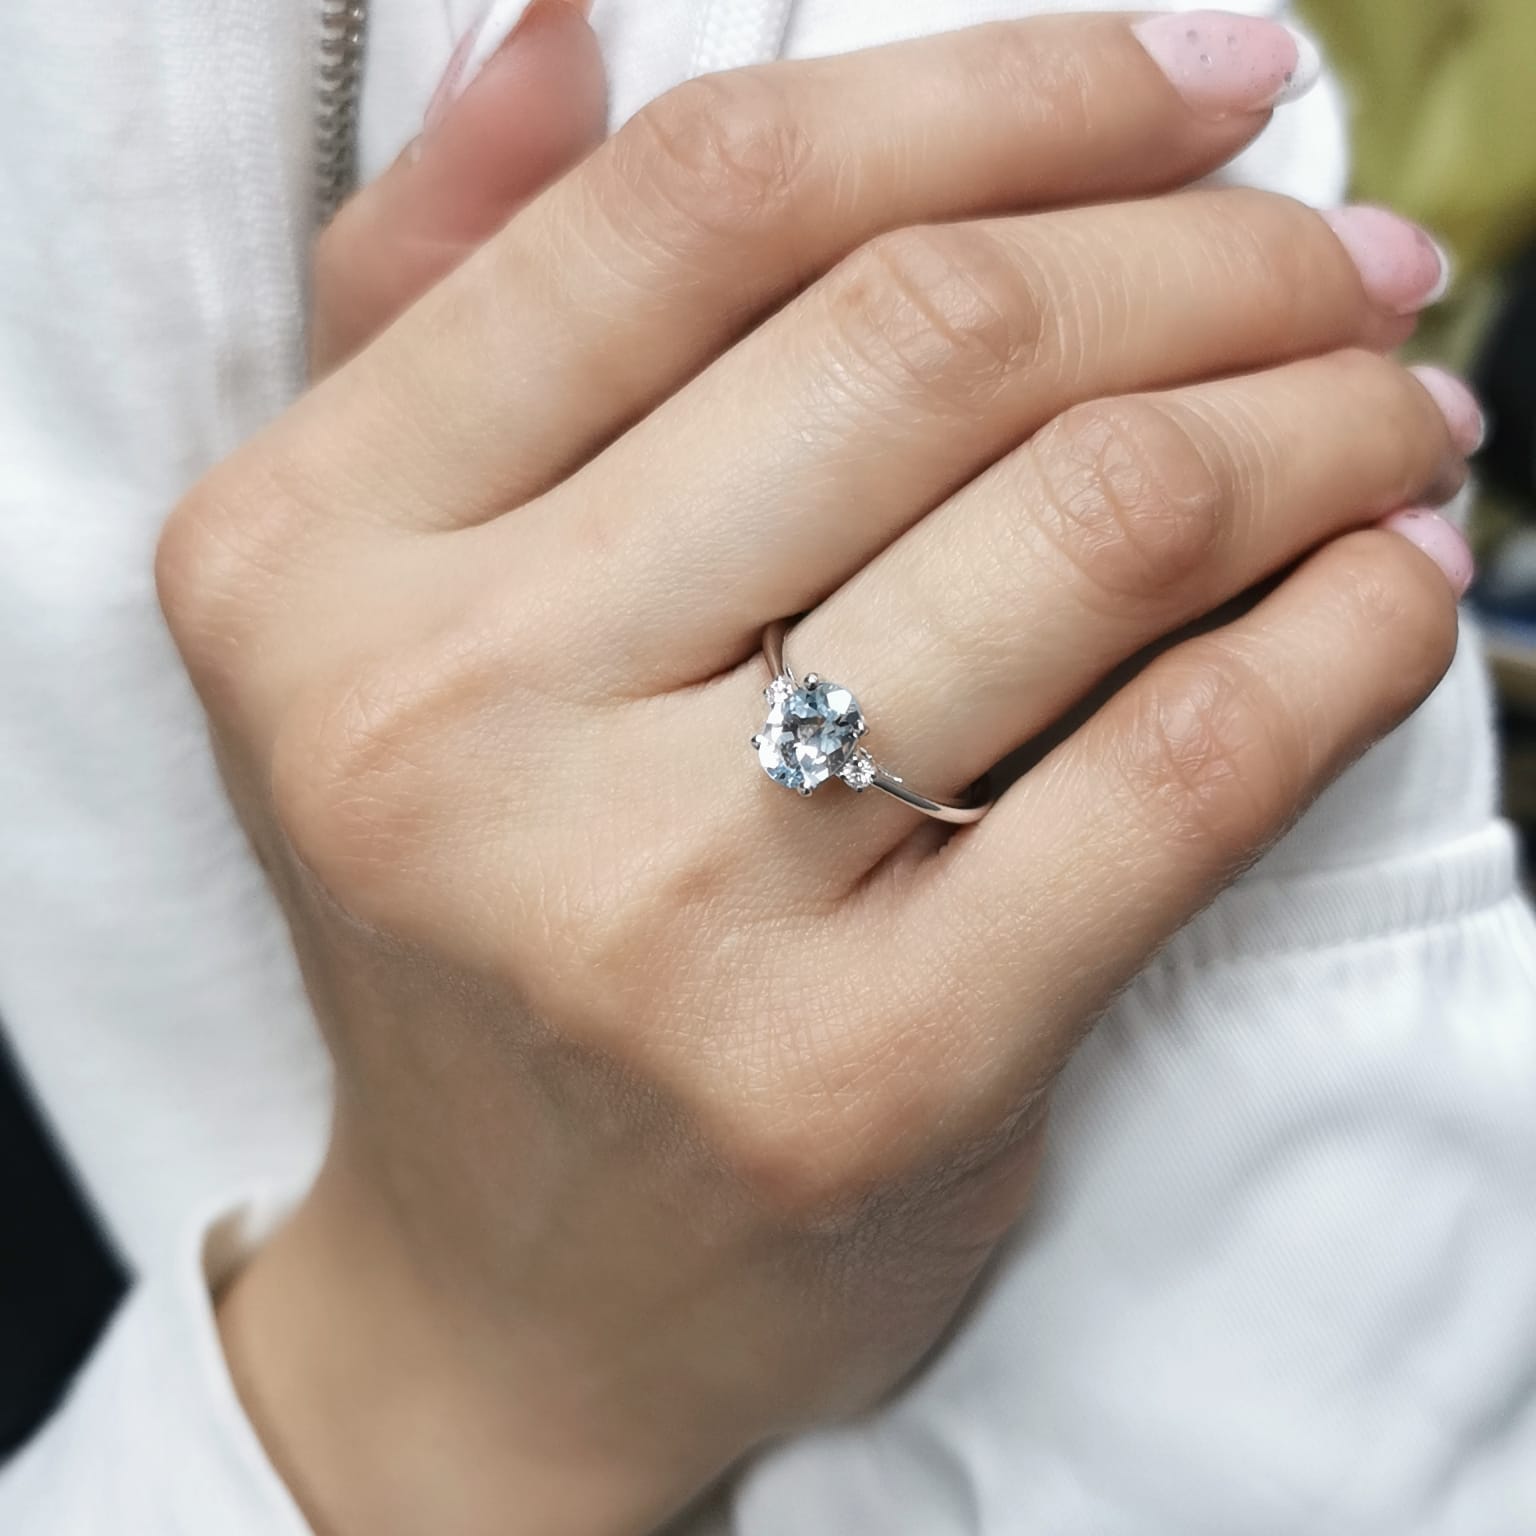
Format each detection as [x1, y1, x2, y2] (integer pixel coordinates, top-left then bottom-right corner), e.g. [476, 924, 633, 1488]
[531, 190, 1442, 693]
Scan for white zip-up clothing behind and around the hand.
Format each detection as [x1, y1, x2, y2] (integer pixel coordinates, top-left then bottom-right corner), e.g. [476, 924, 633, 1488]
[0, 0, 1536, 1536]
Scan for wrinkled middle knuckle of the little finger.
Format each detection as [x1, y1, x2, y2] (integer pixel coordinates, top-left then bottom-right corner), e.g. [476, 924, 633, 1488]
[1117, 636, 1310, 871]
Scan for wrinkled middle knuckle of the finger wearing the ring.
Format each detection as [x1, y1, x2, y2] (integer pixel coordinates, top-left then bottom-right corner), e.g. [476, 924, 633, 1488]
[1034, 396, 1232, 610]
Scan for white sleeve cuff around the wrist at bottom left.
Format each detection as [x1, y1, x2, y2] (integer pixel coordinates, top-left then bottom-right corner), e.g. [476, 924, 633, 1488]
[0, 1200, 312, 1536]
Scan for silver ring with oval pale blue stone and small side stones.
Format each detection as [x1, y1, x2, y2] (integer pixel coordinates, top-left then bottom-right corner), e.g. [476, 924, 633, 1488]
[753, 619, 992, 825]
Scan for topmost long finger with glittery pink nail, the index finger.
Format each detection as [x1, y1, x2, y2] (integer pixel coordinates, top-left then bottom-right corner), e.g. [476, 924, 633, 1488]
[296, 12, 1310, 527]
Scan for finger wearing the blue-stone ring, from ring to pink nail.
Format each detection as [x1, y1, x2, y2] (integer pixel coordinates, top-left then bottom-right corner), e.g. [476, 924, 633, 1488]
[743, 352, 1476, 837]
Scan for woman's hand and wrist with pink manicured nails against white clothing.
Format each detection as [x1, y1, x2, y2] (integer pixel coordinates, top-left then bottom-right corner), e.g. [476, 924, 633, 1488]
[158, 18, 1471, 1536]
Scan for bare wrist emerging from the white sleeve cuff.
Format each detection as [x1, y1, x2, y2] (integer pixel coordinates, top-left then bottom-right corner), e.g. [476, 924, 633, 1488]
[220, 1130, 743, 1536]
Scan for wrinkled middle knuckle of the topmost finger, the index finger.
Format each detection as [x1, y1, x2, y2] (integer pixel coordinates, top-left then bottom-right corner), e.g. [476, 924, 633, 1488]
[614, 69, 813, 241]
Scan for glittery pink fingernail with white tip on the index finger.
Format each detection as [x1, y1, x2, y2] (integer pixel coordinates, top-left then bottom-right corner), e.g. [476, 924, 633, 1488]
[1130, 11, 1321, 117]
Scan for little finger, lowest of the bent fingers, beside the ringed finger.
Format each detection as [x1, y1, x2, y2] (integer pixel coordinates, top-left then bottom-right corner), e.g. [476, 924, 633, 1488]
[903, 515, 1459, 1092]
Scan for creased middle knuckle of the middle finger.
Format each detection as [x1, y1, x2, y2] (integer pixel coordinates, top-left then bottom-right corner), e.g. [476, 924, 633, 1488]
[826, 224, 1049, 418]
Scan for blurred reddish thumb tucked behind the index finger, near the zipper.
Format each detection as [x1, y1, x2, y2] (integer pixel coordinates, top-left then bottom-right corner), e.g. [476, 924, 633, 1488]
[310, 0, 605, 376]
